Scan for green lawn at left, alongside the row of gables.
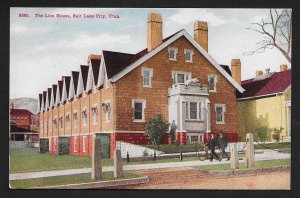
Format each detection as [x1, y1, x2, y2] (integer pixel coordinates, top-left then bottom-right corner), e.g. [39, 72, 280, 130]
[9, 148, 113, 173]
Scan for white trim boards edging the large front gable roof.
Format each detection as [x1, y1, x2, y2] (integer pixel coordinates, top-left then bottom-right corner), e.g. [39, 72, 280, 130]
[111, 30, 245, 93]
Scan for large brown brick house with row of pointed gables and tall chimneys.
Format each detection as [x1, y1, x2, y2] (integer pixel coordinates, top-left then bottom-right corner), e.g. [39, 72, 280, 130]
[39, 13, 244, 157]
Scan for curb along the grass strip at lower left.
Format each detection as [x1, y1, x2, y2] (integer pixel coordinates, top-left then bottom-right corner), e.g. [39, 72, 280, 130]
[31, 176, 149, 189]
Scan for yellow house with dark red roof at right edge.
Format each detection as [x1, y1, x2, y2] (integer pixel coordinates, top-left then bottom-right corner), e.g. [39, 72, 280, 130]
[237, 65, 291, 141]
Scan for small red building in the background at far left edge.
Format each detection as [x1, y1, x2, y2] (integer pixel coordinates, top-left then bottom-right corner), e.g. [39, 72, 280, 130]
[10, 103, 33, 129]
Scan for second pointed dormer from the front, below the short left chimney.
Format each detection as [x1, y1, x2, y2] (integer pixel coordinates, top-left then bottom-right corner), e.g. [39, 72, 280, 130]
[86, 54, 101, 93]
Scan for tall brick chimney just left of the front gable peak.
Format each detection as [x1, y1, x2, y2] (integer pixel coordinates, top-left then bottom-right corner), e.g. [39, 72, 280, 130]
[147, 13, 163, 52]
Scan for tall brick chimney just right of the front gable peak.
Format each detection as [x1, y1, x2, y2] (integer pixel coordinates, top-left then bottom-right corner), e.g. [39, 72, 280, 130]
[194, 21, 208, 52]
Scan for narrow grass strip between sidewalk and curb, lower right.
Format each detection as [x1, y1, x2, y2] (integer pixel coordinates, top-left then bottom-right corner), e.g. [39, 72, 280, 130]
[195, 159, 291, 170]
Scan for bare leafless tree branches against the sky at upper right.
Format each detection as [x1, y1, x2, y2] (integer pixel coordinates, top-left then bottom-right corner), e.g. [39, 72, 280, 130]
[244, 9, 292, 62]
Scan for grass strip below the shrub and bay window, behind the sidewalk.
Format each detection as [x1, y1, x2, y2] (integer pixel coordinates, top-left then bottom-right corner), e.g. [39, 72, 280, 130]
[142, 144, 203, 154]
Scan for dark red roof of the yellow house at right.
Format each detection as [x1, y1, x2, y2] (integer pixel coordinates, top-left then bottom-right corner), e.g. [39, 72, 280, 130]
[237, 70, 291, 99]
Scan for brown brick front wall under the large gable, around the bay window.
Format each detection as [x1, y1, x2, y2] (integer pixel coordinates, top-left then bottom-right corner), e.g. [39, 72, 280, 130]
[115, 37, 237, 133]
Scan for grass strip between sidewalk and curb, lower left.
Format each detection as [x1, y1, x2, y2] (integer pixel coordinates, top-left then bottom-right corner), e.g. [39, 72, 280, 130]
[10, 172, 140, 188]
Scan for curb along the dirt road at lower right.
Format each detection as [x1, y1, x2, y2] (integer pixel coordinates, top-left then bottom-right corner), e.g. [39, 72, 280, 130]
[200, 165, 291, 176]
